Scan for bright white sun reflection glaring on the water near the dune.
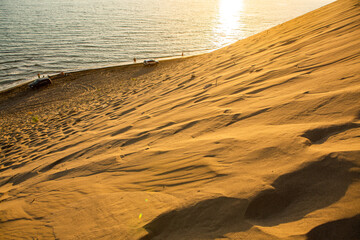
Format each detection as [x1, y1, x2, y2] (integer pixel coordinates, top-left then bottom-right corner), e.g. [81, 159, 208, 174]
[214, 0, 244, 47]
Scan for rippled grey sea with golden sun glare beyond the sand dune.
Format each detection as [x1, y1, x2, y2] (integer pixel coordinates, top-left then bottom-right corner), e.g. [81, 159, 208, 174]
[0, 0, 333, 90]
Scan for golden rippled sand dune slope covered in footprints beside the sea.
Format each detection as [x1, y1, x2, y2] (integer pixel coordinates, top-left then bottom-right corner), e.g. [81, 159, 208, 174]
[0, 0, 360, 240]
